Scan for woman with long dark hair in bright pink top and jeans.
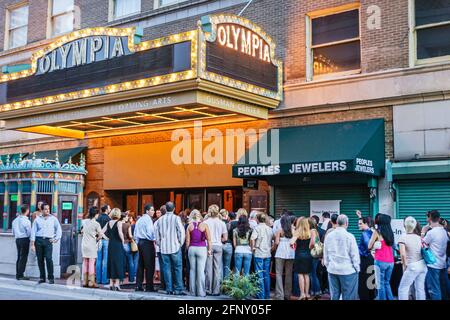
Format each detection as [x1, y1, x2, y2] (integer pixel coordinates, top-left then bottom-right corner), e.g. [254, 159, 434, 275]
[369, 213, 394, 300]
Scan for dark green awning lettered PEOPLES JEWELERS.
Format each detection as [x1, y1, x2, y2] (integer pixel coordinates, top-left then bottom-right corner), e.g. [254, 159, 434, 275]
[233, 119, 385, 178]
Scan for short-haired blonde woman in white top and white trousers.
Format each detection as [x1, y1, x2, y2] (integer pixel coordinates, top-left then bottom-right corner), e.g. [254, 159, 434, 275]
[398, 217, 428, 300]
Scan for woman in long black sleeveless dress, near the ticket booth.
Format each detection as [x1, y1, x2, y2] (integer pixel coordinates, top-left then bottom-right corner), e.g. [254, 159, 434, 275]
[102, 208, 125, 291]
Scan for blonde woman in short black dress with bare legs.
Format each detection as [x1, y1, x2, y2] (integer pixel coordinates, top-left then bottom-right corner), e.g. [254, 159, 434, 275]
[291, 217, 318, 300]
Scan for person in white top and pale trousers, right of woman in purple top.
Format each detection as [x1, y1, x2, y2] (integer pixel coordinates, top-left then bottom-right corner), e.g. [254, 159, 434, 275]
[204, 204, 228, 296]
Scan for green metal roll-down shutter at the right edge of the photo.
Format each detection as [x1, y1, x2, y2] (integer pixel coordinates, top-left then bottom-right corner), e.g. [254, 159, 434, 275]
[397, 179, 450, 226]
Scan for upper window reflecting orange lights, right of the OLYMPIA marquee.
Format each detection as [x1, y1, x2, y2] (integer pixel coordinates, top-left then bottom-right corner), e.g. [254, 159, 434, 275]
[307, 8, 361, 80]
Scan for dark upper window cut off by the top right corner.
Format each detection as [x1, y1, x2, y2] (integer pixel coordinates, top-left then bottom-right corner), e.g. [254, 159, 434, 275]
[410, 0, 450, 65]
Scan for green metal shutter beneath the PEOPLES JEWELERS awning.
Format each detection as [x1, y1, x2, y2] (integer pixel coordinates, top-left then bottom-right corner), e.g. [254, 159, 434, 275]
[275, 185, 370, 240]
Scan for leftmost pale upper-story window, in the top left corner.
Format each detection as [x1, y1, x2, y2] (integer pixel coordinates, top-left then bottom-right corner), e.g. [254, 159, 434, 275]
[5, 5, 28, 49]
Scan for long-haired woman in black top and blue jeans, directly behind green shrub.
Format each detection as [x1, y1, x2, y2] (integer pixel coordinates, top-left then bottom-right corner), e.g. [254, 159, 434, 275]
[233, 215, 252, 275]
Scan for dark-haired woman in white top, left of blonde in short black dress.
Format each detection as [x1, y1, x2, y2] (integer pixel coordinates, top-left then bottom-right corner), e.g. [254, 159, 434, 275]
[274, 215, 295, 300]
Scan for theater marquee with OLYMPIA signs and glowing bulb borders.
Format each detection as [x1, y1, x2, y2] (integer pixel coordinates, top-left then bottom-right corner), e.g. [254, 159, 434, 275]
[0, 15, 282, 138]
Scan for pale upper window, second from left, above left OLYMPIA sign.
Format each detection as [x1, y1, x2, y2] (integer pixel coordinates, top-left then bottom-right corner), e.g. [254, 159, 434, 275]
[50, 0, 75, 37]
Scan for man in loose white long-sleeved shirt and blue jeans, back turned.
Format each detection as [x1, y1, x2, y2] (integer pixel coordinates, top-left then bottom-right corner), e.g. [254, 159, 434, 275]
[323, 214, 360, 300]
